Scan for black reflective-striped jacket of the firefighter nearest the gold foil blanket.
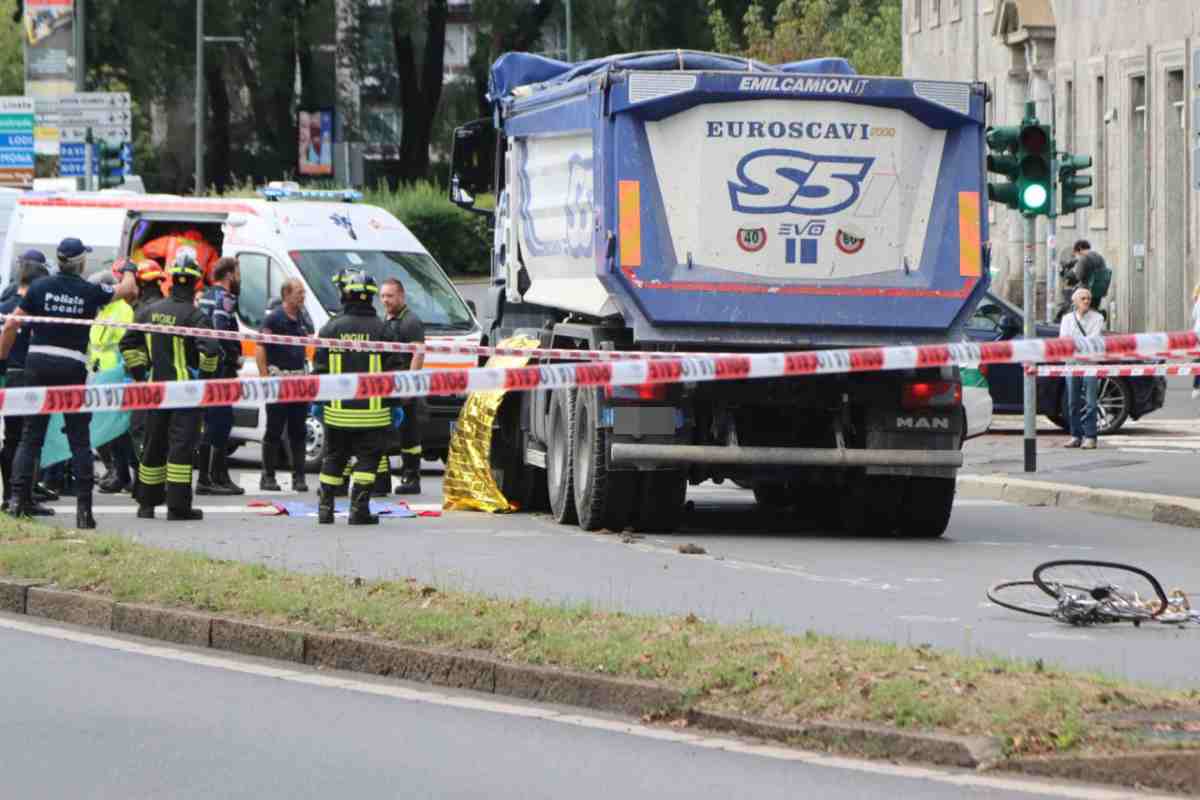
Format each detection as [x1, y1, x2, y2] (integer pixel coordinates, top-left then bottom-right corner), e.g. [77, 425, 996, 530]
[313, 302, 402, 428]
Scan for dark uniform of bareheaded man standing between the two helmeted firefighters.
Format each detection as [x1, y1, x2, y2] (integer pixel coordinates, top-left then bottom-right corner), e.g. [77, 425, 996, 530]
[262, 305, 312, 486]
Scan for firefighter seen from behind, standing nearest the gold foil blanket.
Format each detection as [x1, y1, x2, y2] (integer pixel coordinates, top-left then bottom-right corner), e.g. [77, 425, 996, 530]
[313, 270, 400, 525]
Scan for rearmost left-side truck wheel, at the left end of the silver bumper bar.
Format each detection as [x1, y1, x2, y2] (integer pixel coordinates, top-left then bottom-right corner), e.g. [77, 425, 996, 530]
[571, 389, 637, 531]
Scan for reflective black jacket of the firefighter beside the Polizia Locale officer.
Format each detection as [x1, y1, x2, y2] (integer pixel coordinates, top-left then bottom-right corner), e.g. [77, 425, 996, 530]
[121, 287, 221, 380]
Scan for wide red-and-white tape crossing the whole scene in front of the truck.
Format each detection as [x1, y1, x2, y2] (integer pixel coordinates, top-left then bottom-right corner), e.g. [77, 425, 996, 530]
[7, 331, 1200, 415]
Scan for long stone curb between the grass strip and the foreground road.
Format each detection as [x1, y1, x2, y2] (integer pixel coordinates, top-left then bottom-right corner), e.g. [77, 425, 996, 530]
[0, 578, 988, 772]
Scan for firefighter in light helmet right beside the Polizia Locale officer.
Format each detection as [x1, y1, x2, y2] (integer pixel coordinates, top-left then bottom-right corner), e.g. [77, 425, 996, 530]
[121, 253, 221, 522]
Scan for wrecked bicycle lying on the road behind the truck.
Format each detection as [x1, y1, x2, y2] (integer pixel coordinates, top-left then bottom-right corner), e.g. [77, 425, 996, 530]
[988, 559, 1200, 626]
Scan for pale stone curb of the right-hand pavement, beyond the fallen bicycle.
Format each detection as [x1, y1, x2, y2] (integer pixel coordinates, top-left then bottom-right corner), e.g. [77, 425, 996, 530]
[958, 475, 1200, 528]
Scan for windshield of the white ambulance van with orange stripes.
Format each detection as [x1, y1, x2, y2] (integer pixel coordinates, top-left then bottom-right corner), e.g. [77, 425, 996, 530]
[290, 249, 474, 331]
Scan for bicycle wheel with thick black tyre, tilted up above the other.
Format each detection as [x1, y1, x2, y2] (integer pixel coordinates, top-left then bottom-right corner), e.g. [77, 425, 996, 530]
[1033, 559, 1166, 620]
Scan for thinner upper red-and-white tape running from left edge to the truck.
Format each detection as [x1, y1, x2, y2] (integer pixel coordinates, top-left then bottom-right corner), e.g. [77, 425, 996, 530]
[0, 314, 722, 361]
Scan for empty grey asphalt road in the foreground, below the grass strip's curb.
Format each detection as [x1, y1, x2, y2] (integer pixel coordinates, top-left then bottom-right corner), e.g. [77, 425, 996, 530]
[0, 615, 1135, 800]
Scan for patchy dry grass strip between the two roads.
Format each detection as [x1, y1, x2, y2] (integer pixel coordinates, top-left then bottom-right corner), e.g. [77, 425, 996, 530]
[0, 516, 1200, 756]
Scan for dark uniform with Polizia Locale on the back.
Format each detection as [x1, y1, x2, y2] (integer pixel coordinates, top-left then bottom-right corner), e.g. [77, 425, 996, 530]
[10, 272, 114, 513]
